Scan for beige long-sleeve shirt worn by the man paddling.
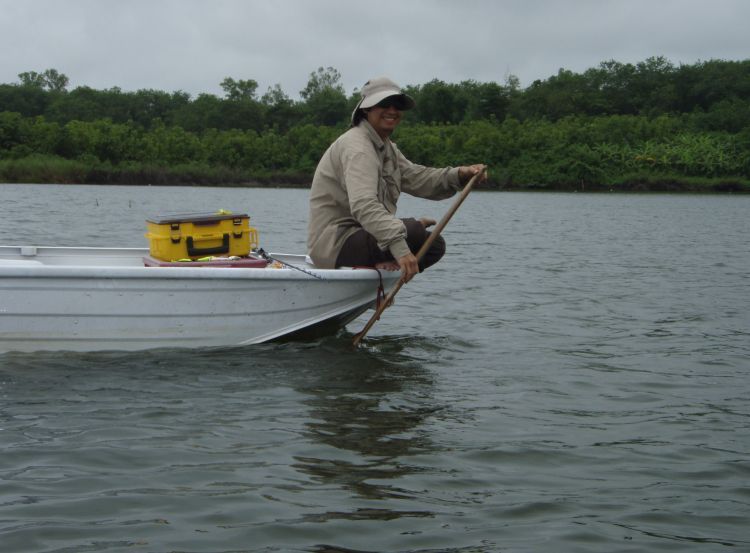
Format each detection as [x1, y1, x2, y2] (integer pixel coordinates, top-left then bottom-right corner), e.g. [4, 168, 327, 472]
[307, 121, 460, 268]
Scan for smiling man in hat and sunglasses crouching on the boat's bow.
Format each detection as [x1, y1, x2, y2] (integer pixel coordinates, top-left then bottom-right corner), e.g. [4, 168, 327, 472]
[307, 77, 486, 282]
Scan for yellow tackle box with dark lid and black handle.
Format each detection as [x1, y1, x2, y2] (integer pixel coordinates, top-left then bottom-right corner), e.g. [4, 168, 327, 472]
[146, 211, 258, 261]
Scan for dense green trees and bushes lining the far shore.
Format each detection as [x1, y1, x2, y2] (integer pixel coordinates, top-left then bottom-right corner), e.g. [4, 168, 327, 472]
[0, 58, 750, 193]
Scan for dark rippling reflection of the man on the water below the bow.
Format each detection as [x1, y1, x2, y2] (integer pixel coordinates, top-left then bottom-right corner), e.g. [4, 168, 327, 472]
[294, 337, 442, 502]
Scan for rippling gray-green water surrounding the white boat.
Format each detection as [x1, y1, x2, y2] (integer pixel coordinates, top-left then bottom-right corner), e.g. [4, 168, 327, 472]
[0, 185, 750, 553]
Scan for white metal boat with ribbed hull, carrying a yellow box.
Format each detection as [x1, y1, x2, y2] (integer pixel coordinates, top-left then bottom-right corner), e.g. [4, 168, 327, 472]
[0, 246, 399, 352]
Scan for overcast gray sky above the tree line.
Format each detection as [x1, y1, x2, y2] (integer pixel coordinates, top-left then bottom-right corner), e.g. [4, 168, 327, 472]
[0, 0, 750, 99]
